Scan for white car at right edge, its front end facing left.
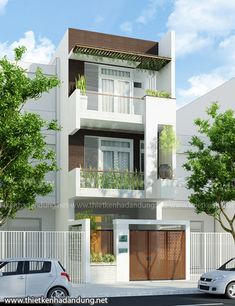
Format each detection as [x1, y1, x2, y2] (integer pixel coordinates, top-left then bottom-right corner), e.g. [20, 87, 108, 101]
[198, 258, 235, 299]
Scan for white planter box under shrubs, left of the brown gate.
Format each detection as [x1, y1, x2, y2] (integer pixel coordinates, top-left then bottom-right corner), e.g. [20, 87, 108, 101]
[91, 263, 117, 283]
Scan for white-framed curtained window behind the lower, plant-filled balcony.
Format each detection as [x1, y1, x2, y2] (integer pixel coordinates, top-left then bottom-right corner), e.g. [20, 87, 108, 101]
[100, 138, 133, 171]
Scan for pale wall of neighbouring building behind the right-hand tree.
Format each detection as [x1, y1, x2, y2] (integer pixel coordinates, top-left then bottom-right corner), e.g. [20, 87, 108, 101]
[175, 78, 235, 232]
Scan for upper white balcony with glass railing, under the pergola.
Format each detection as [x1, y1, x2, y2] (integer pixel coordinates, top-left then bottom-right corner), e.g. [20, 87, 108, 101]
[68, 89, 144, 135]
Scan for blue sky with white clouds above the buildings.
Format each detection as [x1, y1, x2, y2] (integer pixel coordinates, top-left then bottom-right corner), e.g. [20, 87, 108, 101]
[0, 0, 235, 107]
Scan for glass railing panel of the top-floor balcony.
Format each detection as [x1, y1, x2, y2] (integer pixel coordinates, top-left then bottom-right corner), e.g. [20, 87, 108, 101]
[82, 91, 144, 115]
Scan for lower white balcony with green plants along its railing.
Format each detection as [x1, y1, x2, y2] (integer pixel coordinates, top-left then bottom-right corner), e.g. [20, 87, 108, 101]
[69, 168, 145, 198]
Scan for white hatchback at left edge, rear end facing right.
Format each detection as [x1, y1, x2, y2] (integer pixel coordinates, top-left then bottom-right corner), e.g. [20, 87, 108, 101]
[0, 258, 71, 301]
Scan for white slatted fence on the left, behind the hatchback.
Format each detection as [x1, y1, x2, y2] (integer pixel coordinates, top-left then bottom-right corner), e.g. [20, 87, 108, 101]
[0, 231, 84, 284]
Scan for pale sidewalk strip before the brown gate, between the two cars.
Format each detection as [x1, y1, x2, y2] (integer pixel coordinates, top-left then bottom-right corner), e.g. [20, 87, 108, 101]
[72, 280, 199, 297]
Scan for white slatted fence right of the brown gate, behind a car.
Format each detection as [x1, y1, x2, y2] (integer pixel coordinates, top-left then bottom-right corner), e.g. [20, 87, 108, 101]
[190, 233, 235, 280]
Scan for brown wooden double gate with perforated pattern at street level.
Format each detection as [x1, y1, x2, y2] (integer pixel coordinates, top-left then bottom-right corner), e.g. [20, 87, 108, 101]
[130, 231, 185, 280]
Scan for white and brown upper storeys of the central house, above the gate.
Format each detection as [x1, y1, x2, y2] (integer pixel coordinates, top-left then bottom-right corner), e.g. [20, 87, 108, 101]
[52, 29, 176, 230]
